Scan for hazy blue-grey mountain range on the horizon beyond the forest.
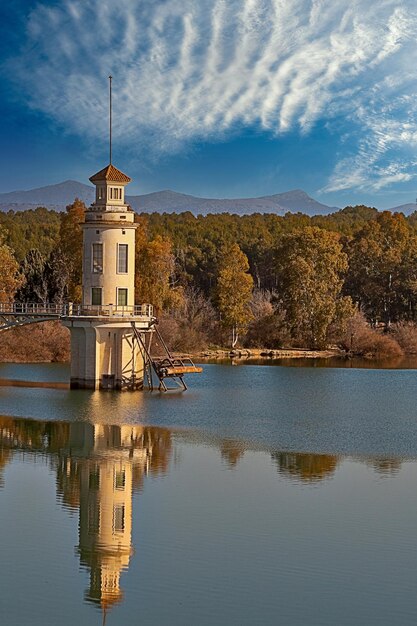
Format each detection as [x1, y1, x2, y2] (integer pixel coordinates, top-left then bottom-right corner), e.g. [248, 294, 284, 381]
[0, 180, 417, 215]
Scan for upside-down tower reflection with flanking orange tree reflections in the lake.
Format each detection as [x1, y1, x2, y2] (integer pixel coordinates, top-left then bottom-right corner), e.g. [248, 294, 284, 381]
[58, 422, 171, 608]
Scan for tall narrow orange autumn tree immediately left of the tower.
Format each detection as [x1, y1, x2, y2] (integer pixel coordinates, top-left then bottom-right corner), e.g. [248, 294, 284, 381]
[59, 198, 86, 302]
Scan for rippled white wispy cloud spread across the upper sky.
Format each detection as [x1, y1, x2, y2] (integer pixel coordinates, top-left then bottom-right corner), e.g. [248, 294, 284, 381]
[7, 0, 417, 191]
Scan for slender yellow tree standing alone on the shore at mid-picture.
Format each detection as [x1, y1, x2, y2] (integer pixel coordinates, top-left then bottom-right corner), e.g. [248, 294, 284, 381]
[217, 243, 253, 348]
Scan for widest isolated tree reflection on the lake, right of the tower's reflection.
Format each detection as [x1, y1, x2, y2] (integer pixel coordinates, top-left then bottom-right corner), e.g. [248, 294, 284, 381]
[271, 452, 338, 482]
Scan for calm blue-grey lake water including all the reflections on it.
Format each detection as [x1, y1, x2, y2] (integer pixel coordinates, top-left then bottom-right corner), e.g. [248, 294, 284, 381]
[0, 363, 417, 626]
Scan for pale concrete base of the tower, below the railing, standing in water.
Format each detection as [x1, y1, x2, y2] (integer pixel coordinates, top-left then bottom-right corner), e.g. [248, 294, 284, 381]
[63, 318, 150, 391]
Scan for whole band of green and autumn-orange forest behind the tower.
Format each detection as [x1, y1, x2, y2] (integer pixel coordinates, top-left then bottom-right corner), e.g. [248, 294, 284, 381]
[0, 200, 417, 354]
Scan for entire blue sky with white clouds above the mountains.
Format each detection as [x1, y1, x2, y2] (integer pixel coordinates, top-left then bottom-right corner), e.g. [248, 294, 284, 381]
[0, 0, 417, 208]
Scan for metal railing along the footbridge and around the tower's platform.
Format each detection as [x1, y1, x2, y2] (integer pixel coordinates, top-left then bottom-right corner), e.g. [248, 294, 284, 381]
[0, 302, 153, 318]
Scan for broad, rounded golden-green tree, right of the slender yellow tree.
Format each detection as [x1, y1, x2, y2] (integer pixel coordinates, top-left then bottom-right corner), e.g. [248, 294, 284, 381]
[276, 226, 353, 347]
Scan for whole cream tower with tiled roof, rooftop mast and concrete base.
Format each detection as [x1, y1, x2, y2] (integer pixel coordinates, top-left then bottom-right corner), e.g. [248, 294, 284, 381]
[62, 77, 154, 389]
